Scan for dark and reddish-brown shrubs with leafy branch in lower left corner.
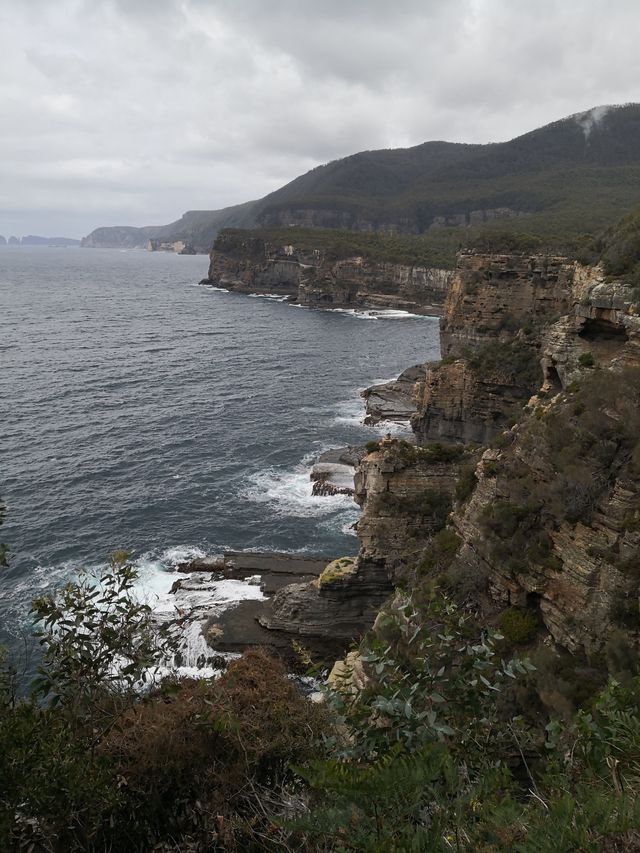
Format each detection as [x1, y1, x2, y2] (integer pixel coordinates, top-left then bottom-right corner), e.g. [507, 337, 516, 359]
[0, 559, 326, 853]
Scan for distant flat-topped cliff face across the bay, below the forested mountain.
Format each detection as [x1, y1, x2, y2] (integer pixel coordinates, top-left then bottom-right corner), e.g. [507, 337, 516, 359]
[205, 234, 452, 314]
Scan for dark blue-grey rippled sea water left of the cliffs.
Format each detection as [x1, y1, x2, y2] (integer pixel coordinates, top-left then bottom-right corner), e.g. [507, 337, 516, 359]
[0, 247, 438, 640]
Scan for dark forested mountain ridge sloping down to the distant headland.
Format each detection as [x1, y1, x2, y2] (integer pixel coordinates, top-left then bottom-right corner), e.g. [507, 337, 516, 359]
[82, 104, 640, 251]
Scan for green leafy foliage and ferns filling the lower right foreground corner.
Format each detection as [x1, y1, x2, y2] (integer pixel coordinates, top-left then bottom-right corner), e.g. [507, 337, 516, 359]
[289, 597, 640, 853]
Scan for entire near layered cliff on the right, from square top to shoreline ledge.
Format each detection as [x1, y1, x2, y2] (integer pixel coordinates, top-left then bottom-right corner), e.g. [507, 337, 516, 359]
[262, 243, 640, 660]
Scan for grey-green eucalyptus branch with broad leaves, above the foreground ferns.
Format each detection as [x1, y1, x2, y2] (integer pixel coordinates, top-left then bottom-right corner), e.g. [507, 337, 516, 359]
[328, 596, 533, 762]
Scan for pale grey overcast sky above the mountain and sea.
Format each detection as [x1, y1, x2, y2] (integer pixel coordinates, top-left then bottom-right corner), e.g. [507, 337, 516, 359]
[0, 0, 640, 237]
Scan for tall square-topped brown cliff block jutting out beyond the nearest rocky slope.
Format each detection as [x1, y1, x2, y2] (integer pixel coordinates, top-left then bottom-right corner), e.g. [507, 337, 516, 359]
[412, 253, 575, 444]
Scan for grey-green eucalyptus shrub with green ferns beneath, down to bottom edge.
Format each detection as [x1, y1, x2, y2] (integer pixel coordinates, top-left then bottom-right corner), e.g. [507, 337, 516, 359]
[297, 597, 531, 853]
